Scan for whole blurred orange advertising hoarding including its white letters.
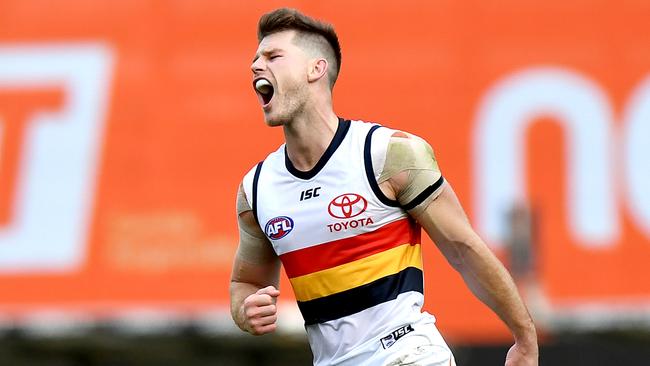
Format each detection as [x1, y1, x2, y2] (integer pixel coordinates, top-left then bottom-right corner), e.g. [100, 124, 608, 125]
[0, 0, 650, 341]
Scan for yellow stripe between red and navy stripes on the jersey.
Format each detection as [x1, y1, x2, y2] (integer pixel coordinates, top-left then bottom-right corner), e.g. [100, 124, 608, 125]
[290, 244, 422, 301]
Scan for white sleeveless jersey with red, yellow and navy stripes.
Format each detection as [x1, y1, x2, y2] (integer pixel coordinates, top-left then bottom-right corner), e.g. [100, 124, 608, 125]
[243, 120, 435, 366]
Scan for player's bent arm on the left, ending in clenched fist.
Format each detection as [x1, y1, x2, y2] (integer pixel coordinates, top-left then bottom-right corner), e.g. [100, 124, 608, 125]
[230, 186, 280, 335]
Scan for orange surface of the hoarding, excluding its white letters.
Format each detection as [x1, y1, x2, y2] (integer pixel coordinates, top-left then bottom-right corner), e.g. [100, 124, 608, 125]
[0, 0, 650, 342]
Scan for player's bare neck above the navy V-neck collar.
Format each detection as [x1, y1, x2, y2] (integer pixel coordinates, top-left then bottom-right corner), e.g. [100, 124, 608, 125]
[284, 99, 338, 171]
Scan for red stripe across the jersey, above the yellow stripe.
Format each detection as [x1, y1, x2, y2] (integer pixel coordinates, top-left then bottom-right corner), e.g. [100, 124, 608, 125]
[280, 218, 420, 278]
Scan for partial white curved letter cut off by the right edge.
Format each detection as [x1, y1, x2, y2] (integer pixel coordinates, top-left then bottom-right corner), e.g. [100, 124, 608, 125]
[622, 77, 650, 237]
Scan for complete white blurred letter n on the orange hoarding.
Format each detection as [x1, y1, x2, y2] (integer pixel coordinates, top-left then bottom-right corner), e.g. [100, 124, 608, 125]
[473, 68, 618, 246]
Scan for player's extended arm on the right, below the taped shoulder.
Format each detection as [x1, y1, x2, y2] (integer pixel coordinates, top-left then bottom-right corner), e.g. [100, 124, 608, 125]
[380, 133, 539, 366]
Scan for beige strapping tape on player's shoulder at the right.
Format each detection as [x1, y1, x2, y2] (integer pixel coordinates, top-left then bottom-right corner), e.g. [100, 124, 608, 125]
[378, 132, 444, 215]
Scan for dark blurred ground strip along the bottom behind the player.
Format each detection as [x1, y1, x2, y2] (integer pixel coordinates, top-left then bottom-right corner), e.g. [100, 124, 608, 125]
[0, 327, 650, 366]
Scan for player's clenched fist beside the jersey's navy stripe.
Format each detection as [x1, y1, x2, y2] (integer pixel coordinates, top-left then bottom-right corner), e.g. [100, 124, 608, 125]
[240, 286, 280, 335]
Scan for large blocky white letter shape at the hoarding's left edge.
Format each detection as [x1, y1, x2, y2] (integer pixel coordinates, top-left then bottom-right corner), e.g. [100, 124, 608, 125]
[0, 43, 112, 273]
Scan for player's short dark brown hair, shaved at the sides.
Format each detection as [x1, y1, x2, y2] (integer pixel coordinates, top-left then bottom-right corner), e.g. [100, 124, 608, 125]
[257, 8, 341, 89]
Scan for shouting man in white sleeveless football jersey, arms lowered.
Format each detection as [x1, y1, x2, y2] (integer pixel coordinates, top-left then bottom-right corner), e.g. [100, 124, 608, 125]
[230, 9, 538, 366]
